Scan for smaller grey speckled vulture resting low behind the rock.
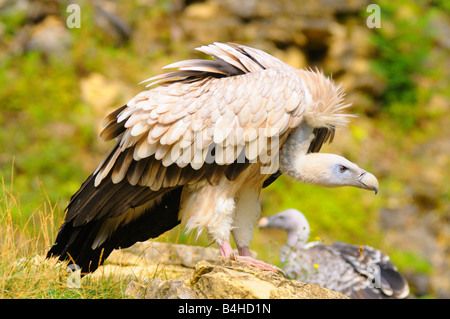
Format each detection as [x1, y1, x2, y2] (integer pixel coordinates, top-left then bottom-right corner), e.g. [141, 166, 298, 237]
[258, 209, 409, 299]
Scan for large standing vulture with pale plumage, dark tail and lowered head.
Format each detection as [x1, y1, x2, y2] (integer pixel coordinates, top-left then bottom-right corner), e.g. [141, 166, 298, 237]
[48, 43, 378, 272]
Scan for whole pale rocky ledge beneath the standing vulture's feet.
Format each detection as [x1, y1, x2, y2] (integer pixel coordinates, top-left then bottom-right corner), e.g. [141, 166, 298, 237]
[90, 241, 346, 299]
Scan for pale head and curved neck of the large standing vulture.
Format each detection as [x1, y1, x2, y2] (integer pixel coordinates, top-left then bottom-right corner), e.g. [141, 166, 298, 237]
[280, 77, 378, 194]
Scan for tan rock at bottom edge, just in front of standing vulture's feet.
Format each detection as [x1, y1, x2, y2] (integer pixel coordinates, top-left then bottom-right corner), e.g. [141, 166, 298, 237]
[127, 257, 346, 299]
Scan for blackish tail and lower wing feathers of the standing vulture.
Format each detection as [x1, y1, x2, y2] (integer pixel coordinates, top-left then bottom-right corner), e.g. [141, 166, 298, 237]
[47, 175, 182, 274]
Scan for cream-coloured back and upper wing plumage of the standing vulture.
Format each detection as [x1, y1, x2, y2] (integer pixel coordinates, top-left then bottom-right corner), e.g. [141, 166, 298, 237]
[95, 43, 348, 190]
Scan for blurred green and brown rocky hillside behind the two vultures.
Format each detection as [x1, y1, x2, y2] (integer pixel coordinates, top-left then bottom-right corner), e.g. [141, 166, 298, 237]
[0, 0, 450, 298]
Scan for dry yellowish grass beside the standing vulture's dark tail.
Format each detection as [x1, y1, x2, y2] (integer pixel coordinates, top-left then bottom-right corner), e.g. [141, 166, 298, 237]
[0, 178, 133, 299]
